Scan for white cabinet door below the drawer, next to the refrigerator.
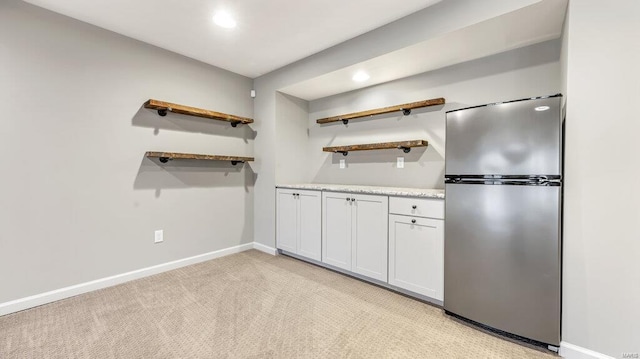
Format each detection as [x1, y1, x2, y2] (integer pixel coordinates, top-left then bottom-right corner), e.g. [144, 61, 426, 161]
[389, 215, 444, 300]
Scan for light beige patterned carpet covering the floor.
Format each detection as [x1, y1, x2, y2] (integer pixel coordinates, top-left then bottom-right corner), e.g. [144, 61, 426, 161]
[0, 250, 557, 359]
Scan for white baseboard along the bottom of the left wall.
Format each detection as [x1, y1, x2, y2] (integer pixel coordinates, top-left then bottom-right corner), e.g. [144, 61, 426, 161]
[0, 242, 255, 316]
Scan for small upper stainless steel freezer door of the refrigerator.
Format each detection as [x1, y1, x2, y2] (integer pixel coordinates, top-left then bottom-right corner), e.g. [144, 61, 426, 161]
[445, 97, 562, 175]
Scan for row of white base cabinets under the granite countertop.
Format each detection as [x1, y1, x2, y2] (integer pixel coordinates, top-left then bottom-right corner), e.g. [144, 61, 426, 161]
[276, 188, 444, 302]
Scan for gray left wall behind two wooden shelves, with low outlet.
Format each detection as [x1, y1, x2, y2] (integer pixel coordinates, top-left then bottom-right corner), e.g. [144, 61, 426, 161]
[0, 0, 255, 303]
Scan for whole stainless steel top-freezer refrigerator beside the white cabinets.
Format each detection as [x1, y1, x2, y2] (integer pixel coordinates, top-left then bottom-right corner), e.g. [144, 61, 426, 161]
[444, 95, 564, 346]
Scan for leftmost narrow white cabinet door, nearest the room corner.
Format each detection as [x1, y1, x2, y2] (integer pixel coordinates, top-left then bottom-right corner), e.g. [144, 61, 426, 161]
[276, 189, 298, 253]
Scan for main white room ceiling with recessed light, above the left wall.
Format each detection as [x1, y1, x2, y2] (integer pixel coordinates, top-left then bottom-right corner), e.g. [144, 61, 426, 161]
[20, 0, 441, 78]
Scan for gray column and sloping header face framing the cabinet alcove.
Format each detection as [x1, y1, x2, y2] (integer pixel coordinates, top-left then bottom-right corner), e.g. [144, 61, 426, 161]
[254, 0, 552, 253]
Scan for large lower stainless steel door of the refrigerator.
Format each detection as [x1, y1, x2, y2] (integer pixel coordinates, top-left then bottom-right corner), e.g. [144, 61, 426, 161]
[444, 184, 562, 346]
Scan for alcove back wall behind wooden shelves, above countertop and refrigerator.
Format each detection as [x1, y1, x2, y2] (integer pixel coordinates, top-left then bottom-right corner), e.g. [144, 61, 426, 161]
[306, 40, 560, 188]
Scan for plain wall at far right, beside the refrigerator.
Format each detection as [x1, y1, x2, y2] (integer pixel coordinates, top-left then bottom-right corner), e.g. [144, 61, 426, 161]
[563, 0, 640, 358]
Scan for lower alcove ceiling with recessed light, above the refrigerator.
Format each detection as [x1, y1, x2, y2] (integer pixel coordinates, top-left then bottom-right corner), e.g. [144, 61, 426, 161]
[280, 0, 567, 101]
